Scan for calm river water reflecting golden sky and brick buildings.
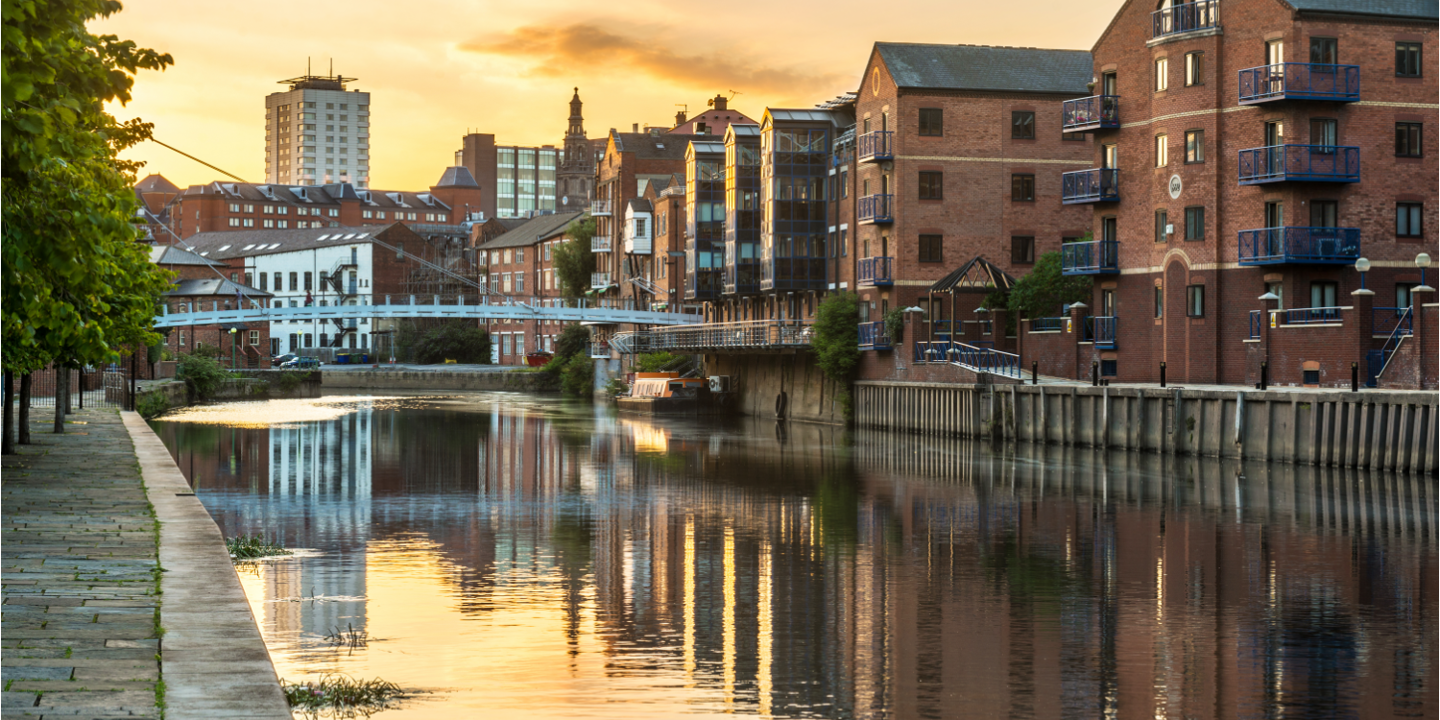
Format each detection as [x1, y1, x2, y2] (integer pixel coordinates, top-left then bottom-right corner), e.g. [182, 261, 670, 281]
[153, 393, 1440, 720]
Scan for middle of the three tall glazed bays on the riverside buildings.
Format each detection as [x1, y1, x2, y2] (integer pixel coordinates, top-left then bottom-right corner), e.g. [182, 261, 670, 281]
[724, 125, 762, 295]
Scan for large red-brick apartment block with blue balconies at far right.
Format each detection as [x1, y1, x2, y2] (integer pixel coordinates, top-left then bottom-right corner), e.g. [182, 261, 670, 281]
[1054, 0, 1440, 386]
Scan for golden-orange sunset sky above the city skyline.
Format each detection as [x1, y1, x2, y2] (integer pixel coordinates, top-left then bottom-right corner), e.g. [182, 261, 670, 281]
[92, 0, 1122, 190]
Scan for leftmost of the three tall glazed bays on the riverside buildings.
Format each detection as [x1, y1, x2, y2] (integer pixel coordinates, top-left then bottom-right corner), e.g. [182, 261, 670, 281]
[685, 143, 726, 300]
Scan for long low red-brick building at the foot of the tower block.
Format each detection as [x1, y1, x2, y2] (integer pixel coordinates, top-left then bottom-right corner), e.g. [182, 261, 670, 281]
[147, 167, 481, 243]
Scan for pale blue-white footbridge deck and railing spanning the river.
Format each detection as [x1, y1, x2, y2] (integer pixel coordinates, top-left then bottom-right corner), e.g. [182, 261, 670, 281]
[154, 295, 704, 328]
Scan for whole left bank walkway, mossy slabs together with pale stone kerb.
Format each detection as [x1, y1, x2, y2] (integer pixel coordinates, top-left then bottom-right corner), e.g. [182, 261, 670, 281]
[0, 409, 289, 720]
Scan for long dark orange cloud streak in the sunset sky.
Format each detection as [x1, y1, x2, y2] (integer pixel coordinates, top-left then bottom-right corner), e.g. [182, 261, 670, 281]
[459, 23, 852, 95]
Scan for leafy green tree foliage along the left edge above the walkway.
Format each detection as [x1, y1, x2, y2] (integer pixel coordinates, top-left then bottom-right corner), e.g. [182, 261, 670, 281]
[0, 0, 173, 372]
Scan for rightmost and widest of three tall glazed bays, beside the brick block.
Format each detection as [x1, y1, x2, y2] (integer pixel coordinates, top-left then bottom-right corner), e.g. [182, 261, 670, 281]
[760, 121, 831, 291]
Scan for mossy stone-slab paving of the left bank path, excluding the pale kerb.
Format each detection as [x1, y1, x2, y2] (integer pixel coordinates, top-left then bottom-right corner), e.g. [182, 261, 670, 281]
[0, 410, 160, 719]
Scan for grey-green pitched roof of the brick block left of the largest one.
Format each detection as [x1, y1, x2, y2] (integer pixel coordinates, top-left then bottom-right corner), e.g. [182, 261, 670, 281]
[876, 41, 1088, 95]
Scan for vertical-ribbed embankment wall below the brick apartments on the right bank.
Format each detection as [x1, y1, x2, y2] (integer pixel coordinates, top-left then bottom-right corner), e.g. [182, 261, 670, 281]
[855, 382, 1440, 474]
